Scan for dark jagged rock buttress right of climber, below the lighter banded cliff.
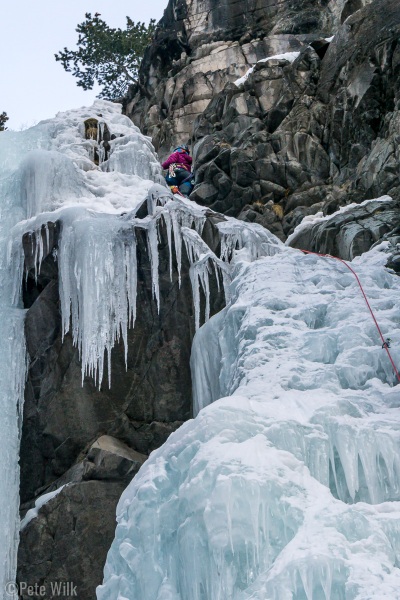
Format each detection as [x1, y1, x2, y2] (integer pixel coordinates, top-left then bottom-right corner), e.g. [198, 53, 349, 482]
[192, 0, 400, 244]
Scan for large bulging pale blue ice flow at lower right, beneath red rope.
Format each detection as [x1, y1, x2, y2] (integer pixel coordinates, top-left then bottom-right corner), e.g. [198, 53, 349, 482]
[97, 240, 400, 600]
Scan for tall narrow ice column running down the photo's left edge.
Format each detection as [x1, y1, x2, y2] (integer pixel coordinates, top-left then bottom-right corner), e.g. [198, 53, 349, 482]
[0, 133, 32, 600]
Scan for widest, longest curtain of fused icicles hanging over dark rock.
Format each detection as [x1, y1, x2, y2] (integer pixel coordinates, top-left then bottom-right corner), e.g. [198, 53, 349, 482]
[50, 211, 141, 385]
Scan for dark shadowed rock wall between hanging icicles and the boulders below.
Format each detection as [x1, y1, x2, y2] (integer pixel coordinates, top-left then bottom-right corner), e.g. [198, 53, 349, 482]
[21, 223, 194, 501]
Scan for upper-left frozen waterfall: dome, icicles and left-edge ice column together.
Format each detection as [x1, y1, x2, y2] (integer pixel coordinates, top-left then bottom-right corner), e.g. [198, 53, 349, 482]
[0, 101, 234, 600]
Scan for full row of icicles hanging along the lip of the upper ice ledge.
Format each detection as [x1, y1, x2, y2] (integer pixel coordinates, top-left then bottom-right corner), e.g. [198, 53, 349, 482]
[9, 184, 278, 386]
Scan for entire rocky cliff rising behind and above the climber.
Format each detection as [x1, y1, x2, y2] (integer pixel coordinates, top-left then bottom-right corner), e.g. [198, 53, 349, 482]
[125, 0, 399, 253]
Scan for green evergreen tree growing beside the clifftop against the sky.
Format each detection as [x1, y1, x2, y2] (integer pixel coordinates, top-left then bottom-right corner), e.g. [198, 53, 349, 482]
[55, 13, 156, 100]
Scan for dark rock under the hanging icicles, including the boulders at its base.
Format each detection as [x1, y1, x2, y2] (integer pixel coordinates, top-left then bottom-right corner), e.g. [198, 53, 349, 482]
[18, 209, 224, 600]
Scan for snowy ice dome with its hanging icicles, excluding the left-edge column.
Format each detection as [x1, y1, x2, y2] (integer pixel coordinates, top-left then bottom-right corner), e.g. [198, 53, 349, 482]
[6, 101, 206, 385]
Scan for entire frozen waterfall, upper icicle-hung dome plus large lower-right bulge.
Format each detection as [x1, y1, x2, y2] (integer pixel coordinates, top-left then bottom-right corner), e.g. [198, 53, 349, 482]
[0, 96, 400, 600]
